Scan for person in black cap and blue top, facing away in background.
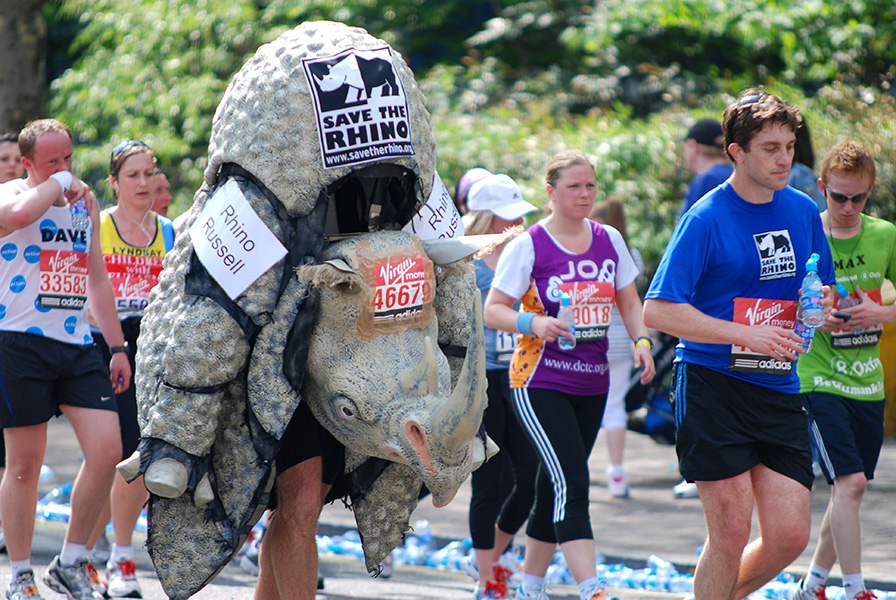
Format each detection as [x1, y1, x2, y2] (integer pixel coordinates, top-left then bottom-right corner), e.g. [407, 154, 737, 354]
[681, 119, 733, 215]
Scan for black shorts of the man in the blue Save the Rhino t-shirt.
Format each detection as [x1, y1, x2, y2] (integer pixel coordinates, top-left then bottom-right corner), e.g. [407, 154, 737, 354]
[675, 363, 814, 489]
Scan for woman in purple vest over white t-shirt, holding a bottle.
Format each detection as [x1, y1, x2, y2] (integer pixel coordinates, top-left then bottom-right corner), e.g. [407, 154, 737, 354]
[485, 150, 654, 600]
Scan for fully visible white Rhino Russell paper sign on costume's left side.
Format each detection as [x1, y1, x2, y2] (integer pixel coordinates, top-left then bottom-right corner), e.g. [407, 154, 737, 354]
[190, 180, 286, 300]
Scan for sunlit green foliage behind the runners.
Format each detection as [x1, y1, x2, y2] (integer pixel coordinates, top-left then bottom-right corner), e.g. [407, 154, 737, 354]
[46, 0, 896, 278]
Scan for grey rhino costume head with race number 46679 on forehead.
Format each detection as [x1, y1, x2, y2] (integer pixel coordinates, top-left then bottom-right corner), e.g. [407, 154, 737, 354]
[300, 232, 484, 506]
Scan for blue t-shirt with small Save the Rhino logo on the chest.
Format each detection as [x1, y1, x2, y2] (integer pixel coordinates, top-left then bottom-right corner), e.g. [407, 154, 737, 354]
[645, 182, 835, 393]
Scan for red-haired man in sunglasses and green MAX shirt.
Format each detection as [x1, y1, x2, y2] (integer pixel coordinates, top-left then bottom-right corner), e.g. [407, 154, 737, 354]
[793, 142, 896, 600]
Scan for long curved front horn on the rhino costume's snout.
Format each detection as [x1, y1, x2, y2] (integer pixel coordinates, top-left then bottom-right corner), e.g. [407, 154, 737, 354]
[433, 290, 486, 450]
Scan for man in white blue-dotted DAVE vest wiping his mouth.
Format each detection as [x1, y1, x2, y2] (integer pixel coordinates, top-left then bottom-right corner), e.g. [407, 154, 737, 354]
[0, 119, 131, 600]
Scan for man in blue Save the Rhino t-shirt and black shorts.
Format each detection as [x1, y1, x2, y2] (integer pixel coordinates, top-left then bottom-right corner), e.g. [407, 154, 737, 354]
[644, 90, 834, 600]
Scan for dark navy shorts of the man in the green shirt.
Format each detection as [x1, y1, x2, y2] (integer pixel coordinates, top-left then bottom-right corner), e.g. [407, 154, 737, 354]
[805, 392, 886, 483]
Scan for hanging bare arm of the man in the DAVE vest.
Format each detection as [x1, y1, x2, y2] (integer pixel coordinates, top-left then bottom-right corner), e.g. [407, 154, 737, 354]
[85, 193, 132, 394]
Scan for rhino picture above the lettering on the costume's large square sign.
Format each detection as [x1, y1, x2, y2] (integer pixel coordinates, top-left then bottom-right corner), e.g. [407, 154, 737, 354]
[308, 52, 401, 112]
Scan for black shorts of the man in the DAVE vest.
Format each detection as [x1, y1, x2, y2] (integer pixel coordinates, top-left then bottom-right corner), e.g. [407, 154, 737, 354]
[0, 331, 116, 428]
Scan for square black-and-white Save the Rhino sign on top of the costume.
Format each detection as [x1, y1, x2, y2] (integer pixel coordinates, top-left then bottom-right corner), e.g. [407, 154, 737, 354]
[302, 46, 414, 169]
